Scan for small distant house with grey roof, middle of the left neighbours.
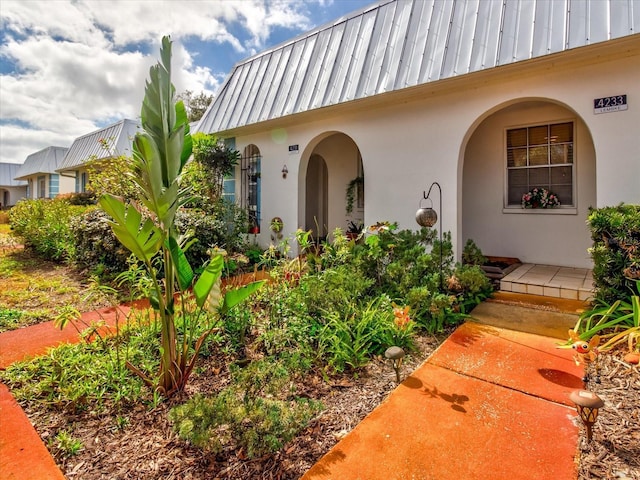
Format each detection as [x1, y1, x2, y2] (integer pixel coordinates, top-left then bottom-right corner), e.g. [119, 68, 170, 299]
[15, 147, 75, 198]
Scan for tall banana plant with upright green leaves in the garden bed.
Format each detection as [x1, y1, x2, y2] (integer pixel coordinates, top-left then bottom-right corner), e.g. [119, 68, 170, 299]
[99, 37, 262, 396]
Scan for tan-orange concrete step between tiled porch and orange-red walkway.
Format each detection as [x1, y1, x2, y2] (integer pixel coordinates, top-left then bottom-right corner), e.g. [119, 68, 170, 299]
[470, 292, 589, 340]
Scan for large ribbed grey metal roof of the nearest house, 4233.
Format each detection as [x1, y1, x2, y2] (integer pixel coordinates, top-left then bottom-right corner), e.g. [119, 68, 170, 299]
[196, 0, 640, 133]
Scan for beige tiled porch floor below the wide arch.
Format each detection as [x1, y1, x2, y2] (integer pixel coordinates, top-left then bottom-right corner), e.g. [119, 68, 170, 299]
[500, 263, 593, 301]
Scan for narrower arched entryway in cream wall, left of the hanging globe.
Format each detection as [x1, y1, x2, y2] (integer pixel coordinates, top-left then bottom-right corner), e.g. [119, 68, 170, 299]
[299, 132, 365, 239]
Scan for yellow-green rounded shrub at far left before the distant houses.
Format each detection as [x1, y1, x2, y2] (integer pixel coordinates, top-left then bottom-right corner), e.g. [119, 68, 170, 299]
[10, 198, 86, 260]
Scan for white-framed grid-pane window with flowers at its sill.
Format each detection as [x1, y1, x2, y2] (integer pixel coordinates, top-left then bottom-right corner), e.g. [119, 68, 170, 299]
[507, 122, 574, 206]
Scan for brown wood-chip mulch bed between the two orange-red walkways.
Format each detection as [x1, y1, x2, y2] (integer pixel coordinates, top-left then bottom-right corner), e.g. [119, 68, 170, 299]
[23, 332, 450, 480]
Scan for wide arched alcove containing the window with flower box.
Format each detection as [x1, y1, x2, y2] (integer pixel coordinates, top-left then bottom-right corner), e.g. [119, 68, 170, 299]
[459, 100, 596, 268]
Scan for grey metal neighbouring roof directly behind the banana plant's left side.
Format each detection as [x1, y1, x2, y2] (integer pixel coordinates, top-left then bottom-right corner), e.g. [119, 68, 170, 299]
[56, 119, 139, 172]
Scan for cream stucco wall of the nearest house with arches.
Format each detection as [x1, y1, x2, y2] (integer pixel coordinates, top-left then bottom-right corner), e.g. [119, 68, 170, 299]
[228, 43, 640, 266]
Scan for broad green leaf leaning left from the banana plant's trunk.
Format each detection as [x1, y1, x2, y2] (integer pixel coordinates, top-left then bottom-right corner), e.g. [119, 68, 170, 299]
[98, 194, 162, 264]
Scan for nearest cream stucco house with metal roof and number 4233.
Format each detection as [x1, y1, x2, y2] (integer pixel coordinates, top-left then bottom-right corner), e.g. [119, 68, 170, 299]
[196, 0, 640, 267]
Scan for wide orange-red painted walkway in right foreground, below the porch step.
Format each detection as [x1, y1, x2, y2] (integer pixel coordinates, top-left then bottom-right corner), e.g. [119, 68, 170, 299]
[302, 323, 583, 480]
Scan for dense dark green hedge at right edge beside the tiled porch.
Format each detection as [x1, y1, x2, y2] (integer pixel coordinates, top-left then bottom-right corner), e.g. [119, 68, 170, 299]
[587, 204, 640, 303]
